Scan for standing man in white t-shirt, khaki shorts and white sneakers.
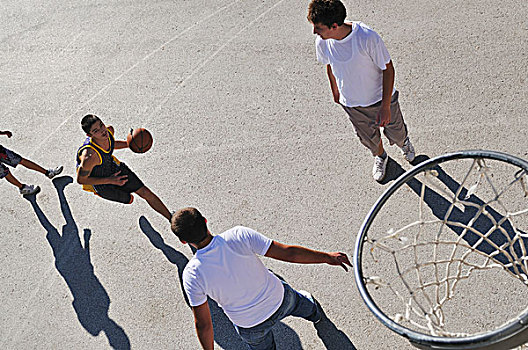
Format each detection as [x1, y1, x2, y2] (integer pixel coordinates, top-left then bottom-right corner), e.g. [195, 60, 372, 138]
[308, 0, 415, 181]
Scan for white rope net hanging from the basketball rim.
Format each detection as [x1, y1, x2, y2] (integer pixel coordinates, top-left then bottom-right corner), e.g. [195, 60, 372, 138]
[363, 158, 528, 344]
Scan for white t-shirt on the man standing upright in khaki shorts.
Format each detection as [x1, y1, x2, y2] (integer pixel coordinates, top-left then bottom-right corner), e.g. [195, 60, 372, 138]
[315, 22, 396, 107]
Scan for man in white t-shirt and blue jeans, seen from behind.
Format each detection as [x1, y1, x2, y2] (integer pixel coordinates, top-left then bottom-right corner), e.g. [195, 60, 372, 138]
[171, 208, 352, 349]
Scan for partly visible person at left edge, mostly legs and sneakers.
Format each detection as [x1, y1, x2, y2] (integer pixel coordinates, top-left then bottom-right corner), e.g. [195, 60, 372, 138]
[0, 131, 62, 195]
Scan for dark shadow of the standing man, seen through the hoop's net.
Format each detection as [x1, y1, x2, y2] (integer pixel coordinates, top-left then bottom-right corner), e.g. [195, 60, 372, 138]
[391, 155, 528, 274]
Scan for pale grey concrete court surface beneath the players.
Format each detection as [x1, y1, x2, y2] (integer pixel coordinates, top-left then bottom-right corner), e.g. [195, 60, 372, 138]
[0, 0, 528, 350]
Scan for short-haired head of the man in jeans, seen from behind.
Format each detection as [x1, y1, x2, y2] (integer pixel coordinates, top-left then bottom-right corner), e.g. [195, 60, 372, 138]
[171, 207, 207, 244]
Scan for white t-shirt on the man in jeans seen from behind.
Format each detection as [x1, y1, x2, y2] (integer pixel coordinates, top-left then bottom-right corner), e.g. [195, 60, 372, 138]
[183, 226, 284, 328]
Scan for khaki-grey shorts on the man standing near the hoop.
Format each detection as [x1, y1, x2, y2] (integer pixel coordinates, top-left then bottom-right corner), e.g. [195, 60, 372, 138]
[342, 91, 407, 155]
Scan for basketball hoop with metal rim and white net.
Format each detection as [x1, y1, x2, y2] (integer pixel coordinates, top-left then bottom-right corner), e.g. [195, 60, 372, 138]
[354, 150, 528, 350]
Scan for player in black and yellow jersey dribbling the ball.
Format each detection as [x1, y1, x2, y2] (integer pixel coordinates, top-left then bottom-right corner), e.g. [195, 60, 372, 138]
[77, 114, 171, 220]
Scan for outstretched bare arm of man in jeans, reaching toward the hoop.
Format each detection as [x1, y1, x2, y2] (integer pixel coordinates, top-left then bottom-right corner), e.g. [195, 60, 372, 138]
[265, 241, 352, 271]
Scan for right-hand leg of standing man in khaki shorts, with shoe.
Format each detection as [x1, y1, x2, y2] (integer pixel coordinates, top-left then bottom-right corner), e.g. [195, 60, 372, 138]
[383, 91, 416, 162]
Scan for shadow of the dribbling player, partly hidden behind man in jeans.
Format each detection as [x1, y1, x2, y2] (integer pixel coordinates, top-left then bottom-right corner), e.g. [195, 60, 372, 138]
[139, 216, 308, 350]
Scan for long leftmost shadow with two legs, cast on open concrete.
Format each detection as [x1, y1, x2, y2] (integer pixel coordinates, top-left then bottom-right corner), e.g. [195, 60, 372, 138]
[26, 176, 130, 350]
